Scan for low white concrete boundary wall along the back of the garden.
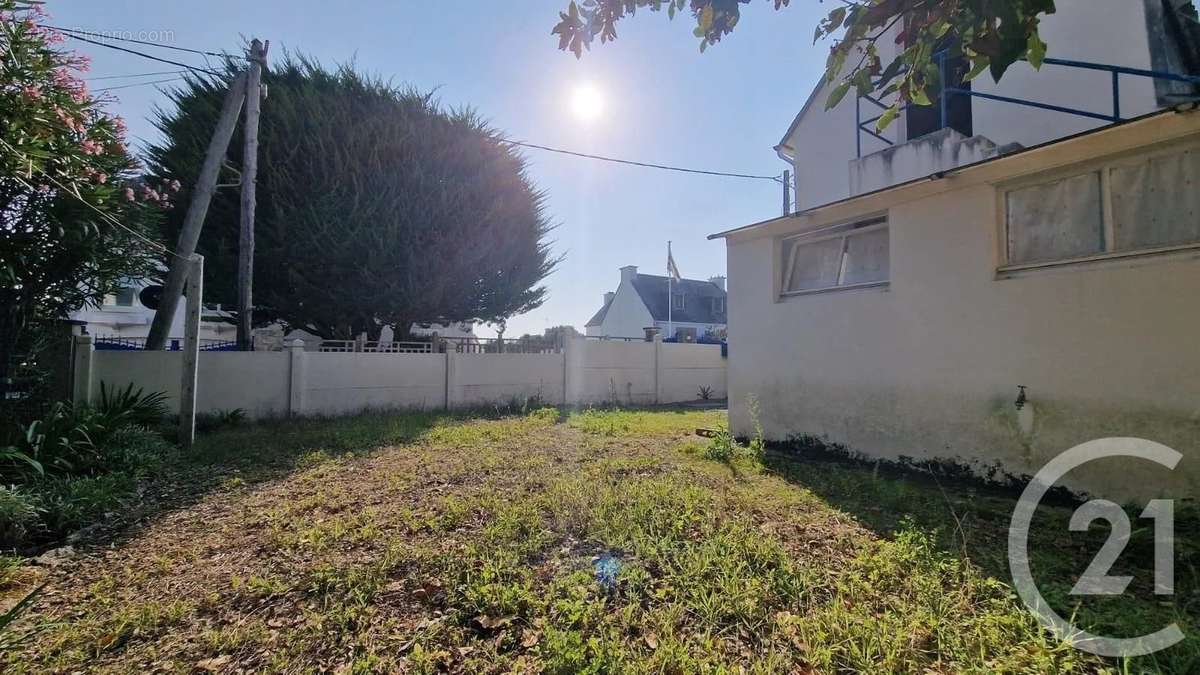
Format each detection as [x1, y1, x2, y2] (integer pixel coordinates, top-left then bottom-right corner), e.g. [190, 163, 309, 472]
[82, 338, 726, 417]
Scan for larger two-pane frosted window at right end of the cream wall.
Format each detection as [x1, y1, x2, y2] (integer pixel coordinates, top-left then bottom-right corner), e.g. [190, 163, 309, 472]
[1004, 149, 1200, 265]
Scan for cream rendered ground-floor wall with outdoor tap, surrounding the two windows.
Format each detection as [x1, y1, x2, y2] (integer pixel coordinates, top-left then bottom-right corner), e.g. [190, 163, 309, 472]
[728, 115, 1200, 498]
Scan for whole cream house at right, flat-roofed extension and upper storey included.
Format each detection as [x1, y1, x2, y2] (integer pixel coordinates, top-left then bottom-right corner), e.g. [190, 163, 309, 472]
[710, 0, 1200, 498]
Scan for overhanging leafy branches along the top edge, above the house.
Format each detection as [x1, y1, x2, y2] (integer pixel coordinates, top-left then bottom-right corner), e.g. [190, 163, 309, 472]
[552, 0, 1055, 127]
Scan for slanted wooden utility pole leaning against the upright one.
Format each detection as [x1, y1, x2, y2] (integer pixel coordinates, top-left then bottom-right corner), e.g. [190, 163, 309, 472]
[146, 73, 246, 350]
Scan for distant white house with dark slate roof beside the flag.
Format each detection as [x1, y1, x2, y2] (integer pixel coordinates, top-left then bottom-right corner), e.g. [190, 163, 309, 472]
[584, 265, 726, 342]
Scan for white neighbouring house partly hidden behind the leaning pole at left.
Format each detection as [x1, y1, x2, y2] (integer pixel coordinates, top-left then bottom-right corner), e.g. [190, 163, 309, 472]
[68, 280, 238, 347]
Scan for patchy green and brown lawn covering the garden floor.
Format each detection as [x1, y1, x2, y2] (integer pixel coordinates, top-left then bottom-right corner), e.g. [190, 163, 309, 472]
[0, 408, 1200, 674]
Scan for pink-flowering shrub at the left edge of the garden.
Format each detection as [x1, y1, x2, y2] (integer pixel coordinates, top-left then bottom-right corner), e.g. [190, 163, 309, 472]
[0, 0, 170, 393]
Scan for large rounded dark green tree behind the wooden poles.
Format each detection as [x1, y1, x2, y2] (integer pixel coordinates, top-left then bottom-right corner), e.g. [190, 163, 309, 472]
[150, 56, 557, 339]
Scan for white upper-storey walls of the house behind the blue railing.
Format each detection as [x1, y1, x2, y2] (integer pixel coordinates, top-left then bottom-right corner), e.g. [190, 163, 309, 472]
[785, 0, 1157, 210]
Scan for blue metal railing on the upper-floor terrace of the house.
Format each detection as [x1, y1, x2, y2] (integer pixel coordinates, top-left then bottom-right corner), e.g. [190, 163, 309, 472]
[854, 50, 1200, 159]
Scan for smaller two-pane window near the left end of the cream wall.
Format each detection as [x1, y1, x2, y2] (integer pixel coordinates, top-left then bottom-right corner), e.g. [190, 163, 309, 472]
[781, 219, 890, 294]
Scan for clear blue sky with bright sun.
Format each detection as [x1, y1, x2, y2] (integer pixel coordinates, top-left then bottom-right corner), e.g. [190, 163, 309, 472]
[46, 0, 828, 336]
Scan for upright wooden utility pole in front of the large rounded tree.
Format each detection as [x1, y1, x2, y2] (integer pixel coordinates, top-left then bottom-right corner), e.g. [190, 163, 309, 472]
[238, 38, 270, 351]
